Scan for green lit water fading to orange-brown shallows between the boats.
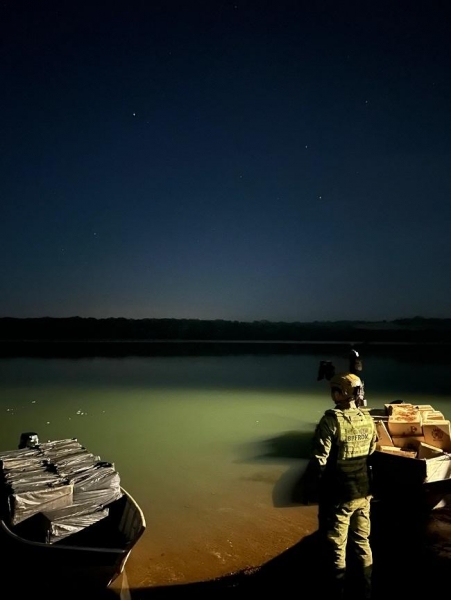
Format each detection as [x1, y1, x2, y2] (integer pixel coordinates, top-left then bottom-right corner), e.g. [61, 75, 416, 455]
[0, 354, 451, 587]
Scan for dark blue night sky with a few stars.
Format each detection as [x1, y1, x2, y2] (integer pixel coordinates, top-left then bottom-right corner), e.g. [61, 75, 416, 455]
[0, 0, 451, 322]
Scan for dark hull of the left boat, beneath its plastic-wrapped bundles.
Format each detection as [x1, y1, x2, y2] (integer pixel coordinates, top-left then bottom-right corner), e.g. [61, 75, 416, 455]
[0, 434, 146, 597]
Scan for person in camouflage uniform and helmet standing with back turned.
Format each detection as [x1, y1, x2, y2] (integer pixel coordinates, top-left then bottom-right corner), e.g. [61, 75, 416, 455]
[305, 373, 376, 600]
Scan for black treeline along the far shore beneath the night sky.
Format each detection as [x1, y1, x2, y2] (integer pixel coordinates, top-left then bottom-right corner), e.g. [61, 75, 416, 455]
[0, 317, 451, 344]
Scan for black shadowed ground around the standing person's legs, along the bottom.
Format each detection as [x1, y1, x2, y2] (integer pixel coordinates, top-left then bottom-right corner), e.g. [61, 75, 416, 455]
[124, 502, 451, 600]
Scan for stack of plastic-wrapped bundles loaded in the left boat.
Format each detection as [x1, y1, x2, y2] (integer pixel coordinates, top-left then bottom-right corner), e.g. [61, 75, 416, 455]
[0, 439, 122, 544]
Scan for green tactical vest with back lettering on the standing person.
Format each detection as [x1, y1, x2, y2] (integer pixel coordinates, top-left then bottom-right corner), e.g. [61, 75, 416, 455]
[326, 408, 374, 501]
